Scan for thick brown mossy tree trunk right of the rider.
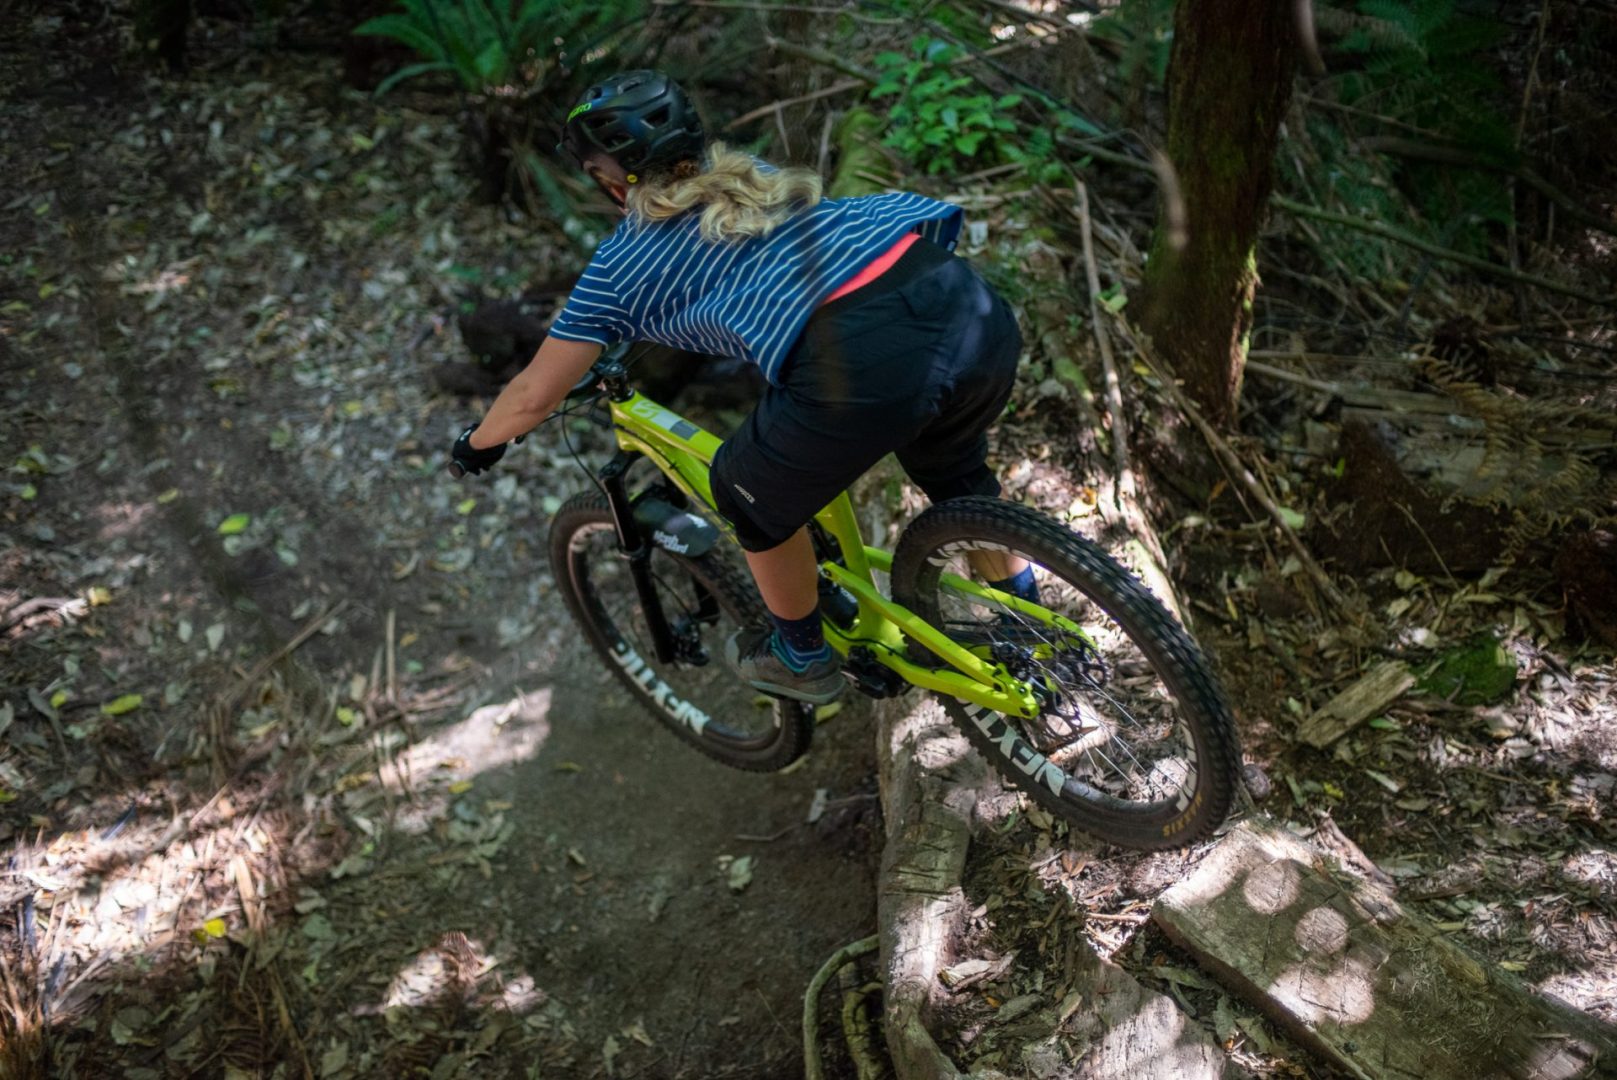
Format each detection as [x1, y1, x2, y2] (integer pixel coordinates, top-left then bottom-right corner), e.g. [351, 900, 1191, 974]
[1143, 0, 1297, 425]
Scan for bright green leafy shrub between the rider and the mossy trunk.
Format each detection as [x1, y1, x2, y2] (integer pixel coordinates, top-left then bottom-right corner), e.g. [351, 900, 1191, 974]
[870, 37, 1096, 181]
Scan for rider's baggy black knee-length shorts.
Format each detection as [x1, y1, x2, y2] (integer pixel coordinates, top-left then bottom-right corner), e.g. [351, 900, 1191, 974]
[713, 239, 1022, 551]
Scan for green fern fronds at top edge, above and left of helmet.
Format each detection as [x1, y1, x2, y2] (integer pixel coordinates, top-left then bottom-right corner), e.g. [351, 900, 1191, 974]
[354, 0, 644, 94]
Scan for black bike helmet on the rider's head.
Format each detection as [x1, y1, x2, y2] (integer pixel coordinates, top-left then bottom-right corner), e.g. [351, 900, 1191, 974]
[561, 71, 707, 184]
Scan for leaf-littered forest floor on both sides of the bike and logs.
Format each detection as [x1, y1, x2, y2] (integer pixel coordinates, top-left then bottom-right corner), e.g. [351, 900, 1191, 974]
[0, 8, 1617, 1077]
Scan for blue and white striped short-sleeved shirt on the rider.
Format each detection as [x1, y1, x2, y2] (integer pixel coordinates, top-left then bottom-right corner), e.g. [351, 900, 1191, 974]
[550, 192, 964, 385]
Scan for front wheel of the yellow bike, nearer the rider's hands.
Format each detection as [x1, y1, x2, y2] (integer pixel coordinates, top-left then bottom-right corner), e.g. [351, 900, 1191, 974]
[550, 491, 813, 771]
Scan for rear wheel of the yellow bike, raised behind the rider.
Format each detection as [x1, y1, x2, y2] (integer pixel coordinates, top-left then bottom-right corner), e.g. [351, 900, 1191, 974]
[893, 498, 1240, 850]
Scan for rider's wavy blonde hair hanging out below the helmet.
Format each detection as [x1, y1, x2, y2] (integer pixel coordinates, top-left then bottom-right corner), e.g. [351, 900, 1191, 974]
[626, 142, 820, 243]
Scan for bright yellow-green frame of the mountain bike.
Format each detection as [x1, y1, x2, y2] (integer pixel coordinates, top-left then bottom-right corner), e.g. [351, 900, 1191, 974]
[610, 391, 1047, 716]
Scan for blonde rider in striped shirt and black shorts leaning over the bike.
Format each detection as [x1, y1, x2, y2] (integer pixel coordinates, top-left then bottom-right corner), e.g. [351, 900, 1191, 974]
[453, 71, 1038, 703]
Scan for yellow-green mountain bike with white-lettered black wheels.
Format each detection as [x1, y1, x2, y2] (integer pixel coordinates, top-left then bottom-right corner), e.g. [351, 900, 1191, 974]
[478, 346, 1240, 849]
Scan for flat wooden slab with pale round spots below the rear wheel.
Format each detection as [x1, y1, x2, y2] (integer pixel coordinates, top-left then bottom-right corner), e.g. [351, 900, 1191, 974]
[1151, 818, 1617, 1080]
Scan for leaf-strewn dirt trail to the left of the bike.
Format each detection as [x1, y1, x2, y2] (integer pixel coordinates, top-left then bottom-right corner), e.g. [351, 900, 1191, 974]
[0, 16, 875, 1077]
